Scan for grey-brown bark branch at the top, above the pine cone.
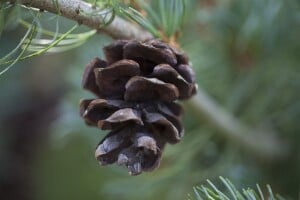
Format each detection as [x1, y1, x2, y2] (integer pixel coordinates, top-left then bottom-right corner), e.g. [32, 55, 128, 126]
[9, 0, 152, 40]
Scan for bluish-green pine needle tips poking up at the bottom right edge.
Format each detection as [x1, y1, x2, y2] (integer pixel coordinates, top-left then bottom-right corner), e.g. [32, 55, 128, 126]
[188, 177, 284, 200]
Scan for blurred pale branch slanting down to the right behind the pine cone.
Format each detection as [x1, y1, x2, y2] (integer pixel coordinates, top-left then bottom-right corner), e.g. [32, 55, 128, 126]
[185, 87, 288, 161]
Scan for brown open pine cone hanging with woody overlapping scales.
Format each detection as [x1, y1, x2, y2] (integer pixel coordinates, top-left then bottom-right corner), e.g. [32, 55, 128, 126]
[80, 40, 196, 175]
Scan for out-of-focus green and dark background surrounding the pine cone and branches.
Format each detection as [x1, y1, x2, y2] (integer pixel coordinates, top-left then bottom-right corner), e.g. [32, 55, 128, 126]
[0, 0, 300, 200]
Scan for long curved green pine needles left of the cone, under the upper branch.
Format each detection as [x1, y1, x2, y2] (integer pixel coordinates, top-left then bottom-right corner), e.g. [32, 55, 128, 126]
[0, 1, 110, 75]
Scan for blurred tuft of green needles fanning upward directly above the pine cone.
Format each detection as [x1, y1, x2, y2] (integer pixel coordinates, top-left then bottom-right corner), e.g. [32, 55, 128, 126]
[112, 0, 186, 39]
